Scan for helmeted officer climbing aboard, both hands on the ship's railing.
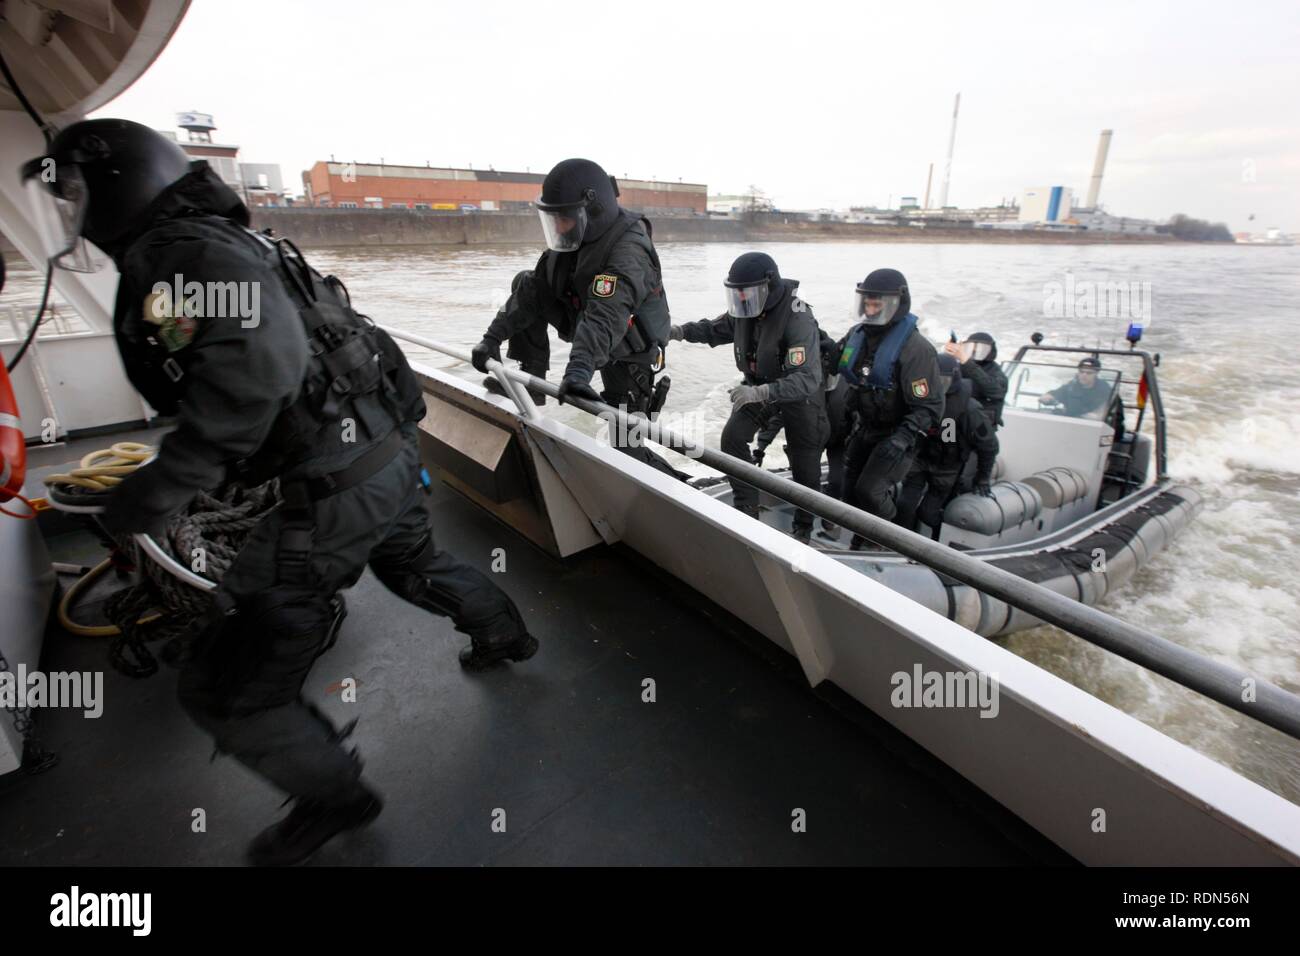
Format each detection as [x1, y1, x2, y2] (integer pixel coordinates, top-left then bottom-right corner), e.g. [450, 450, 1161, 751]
[472, 159, 683, 477]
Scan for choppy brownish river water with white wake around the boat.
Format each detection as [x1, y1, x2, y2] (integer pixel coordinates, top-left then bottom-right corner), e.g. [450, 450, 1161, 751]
[7, 243, 1300, 803]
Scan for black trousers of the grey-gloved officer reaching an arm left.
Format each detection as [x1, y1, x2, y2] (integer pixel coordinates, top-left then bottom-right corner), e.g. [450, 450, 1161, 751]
[722, 392, 831, 528]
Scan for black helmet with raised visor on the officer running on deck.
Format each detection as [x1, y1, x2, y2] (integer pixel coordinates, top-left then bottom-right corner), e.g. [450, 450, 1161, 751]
[22, 120, 190, 261]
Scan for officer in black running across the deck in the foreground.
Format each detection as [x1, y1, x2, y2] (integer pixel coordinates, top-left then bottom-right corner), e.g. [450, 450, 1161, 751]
[26, 120, 537, 864]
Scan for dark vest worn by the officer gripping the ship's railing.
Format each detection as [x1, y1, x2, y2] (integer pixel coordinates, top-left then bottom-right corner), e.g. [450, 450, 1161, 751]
[538, 209, 672, 359]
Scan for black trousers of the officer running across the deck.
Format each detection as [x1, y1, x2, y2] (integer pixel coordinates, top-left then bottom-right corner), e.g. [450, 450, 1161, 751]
[179, 424, 525, 804]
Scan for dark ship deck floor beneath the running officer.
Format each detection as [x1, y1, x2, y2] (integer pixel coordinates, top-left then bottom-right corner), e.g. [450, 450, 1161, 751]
[0, 432, 1073, 866]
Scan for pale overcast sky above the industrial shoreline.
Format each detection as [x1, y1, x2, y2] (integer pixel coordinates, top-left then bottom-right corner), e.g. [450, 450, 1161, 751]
[98, 0, 1300, 232]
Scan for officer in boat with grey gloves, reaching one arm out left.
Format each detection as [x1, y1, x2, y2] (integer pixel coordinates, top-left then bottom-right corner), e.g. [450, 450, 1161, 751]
[671, 252, 829, 542]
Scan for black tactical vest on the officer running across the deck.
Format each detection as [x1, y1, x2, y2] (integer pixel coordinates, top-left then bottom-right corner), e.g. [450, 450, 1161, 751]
[120, 220, 421, 486]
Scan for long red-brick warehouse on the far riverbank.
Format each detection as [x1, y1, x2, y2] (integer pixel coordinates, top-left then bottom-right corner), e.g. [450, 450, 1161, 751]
[303, 161, 709, 216]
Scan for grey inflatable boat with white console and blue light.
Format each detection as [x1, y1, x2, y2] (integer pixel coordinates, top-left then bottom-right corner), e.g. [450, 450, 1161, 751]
[699, 334, 1201, 637]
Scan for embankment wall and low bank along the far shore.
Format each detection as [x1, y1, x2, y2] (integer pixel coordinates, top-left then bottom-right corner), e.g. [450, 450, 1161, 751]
[245, 207, 1177, 248]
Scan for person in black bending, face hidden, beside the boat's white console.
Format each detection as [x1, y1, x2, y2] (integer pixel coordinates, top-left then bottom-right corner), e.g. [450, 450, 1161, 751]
[897, 352, 997, 541]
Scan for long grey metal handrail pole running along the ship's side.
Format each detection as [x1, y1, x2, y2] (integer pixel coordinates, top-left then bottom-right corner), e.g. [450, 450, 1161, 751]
[384, 326, 1300, 739]
